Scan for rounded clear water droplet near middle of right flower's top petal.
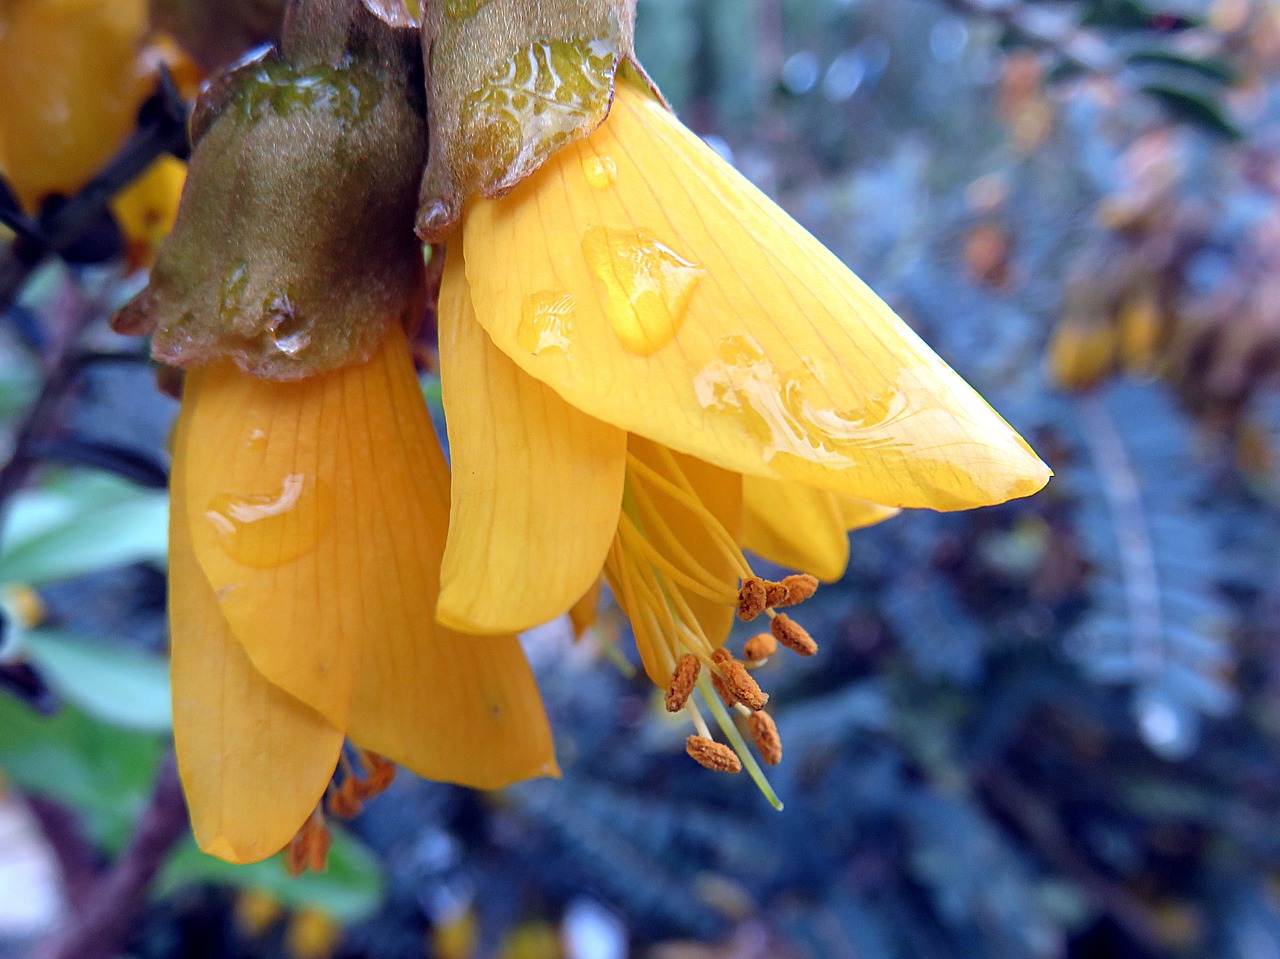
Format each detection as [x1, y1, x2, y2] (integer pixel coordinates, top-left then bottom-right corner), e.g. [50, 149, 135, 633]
[582, 227, 707, 356]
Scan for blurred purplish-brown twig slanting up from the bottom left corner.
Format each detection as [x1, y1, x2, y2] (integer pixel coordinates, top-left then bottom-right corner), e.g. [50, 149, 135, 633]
[31, 754, 187, 959]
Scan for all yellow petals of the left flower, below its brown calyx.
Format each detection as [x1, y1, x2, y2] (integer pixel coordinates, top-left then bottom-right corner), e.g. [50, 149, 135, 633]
[169, 325, 556, 862]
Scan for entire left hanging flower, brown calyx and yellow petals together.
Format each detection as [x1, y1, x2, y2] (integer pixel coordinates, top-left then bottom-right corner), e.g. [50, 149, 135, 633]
[116, 4, 556, 869]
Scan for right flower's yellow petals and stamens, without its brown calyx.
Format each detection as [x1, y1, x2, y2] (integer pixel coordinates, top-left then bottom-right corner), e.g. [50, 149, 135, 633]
[438, 78, 1050, 771]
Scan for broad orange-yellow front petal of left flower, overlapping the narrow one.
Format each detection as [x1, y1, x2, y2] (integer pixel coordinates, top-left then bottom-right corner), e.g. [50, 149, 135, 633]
[186, 329, 554, 786]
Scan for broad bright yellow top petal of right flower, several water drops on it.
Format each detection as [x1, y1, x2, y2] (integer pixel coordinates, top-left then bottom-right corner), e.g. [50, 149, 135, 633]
[463, 82, 1050, 510]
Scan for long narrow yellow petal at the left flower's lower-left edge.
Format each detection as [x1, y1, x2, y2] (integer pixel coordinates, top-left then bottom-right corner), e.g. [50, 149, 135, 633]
[169, 394, 343, 863]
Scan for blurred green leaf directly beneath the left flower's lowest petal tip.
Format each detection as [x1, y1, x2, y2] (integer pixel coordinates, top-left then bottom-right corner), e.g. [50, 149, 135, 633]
[157, 830, 383, 923]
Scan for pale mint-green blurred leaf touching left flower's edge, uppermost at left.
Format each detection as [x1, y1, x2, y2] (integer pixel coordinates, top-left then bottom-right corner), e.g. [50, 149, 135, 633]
[0, 472, 169, 584]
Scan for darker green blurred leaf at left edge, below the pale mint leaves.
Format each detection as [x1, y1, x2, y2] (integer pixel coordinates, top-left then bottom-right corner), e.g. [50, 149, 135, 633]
[0, 695, 168, 850]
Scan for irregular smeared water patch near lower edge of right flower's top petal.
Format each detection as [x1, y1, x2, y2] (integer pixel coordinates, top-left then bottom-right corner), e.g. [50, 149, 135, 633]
[694, 334, 919, 467]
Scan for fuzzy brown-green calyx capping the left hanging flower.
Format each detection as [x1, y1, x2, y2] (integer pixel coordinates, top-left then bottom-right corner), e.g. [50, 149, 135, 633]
[116, 0, 426, 380]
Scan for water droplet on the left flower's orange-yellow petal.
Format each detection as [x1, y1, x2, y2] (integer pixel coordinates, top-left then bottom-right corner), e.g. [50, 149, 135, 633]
[205, 472, 333, 568]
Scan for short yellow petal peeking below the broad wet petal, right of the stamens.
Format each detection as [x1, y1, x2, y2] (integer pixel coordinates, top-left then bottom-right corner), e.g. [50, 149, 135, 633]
[742, 476, 897, 583]
